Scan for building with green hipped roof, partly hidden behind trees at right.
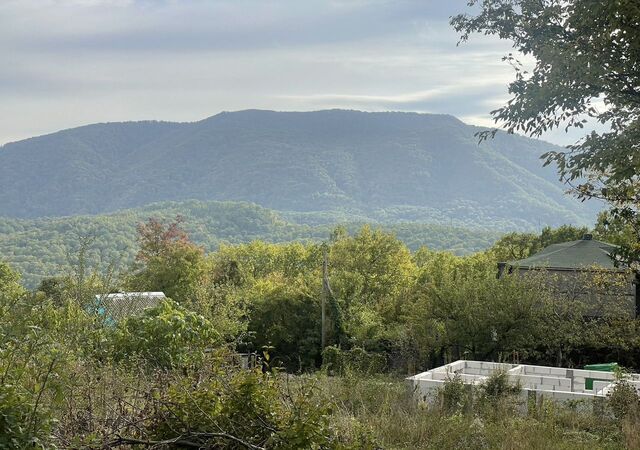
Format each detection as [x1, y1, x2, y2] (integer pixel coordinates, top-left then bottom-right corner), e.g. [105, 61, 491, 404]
[498, 234, 640, 317]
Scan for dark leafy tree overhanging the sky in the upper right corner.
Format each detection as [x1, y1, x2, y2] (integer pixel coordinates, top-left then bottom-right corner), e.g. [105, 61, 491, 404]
[451, 0, 640, 262]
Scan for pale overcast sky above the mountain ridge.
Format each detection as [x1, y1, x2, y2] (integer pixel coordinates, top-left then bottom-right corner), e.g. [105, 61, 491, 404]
[0, 0, 580, 144]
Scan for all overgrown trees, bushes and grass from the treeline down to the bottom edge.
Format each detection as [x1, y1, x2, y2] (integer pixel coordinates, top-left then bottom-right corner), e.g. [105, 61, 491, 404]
[0, 214, 640, 448]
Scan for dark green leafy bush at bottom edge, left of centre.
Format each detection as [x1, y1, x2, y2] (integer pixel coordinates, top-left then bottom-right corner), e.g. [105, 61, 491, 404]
[149, 363, 335, 449]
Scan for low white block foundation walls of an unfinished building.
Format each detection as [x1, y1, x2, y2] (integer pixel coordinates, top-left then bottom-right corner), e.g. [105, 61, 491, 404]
[407, 360, 640, 401]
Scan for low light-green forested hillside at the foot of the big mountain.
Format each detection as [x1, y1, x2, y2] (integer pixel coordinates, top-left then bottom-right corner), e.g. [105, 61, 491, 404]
[0, 201, 498, 287]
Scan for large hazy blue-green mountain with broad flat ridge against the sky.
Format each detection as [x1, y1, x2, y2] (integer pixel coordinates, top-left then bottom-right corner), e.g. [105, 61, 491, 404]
[0, 110, 595, 229]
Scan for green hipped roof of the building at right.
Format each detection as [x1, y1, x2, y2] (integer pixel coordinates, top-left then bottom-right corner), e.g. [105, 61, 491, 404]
[506, 235, 621, 270]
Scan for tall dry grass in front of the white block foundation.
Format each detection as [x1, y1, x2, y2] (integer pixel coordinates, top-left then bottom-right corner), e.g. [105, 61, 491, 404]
[305, 375, 640, 450]
